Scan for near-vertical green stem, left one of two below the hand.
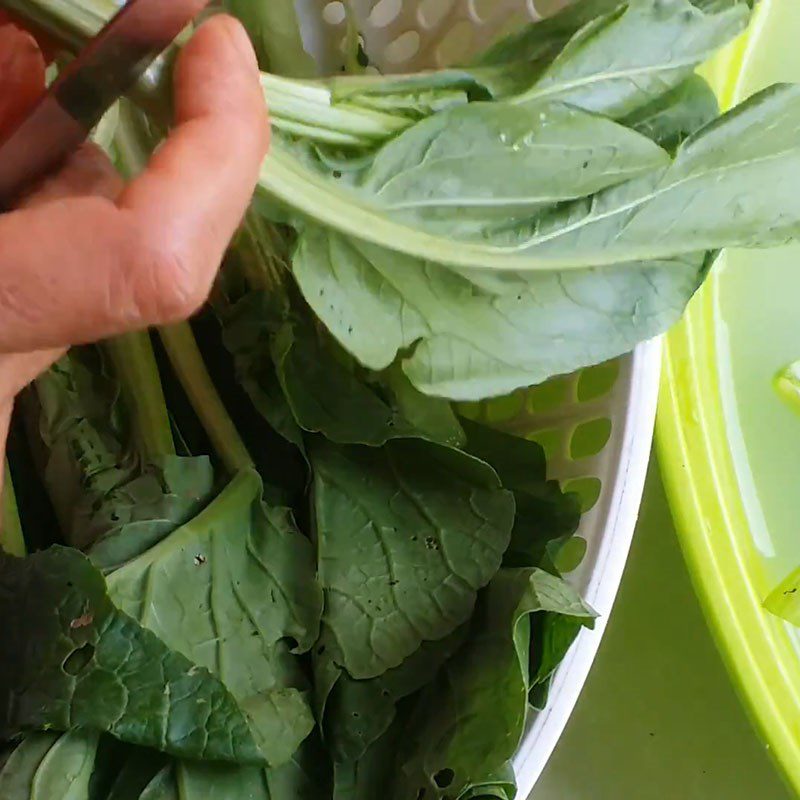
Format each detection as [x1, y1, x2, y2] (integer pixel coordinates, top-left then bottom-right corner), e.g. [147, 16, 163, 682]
[103, 332, 175, 462]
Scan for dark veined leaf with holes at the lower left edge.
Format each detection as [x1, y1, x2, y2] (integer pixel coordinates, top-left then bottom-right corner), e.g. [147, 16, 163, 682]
[0, 547, 263, 763]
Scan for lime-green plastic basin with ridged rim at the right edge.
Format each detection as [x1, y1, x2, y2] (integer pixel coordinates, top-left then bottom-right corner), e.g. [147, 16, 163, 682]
[656, 0, 800, 794]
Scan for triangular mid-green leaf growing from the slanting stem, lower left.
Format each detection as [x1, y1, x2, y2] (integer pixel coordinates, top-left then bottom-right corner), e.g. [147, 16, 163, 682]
[109, 471, 321, 765]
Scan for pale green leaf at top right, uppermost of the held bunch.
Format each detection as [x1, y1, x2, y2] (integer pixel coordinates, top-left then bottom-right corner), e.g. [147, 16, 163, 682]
[516, 0, 750, 119]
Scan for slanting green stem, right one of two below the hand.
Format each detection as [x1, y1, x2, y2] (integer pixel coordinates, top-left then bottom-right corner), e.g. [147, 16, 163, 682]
[159, 322, 253, 474]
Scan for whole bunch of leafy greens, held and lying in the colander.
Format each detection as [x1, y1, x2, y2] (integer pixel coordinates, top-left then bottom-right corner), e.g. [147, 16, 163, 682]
[0, 0, 800, 800]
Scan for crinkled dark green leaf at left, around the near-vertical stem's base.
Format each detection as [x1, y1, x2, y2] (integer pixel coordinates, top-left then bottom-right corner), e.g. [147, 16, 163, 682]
[36, 349, 214, 569]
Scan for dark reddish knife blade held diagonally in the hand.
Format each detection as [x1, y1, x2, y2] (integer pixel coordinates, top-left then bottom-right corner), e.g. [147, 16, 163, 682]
[0, 0, 207, 207]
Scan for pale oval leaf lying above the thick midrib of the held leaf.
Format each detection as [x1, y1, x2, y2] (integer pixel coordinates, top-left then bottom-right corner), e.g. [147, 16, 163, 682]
[361, 103, 669, 238]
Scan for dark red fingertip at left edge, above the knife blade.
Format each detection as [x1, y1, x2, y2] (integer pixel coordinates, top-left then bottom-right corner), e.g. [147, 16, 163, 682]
[0, 24, 45, 136]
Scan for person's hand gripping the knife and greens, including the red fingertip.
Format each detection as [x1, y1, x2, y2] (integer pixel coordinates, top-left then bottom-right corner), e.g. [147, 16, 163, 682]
[0, 10, 269, 456]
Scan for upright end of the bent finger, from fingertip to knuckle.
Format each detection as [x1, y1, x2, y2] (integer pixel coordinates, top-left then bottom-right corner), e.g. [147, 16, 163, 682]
[118, 15, 269, 318]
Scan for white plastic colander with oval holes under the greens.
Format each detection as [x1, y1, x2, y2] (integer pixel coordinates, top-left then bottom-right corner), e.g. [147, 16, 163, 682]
[295, 0, 661, 798]
